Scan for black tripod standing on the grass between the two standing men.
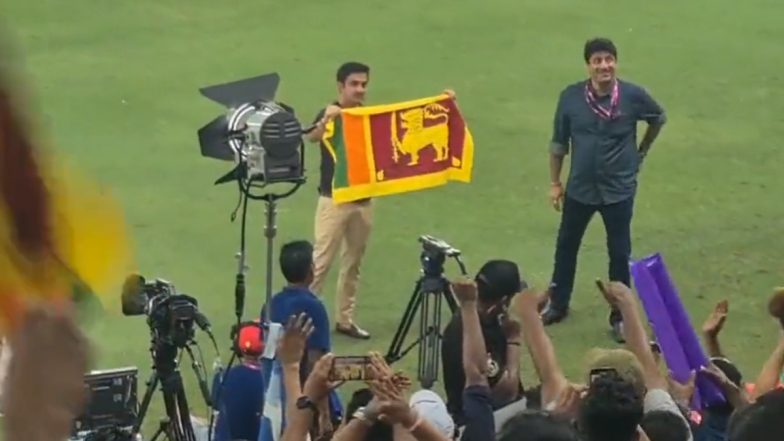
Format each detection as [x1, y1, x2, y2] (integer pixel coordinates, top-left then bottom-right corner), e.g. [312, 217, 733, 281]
[385, 247, 466, 389]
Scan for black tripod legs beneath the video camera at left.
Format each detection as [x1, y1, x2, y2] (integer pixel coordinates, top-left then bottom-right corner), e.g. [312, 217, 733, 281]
[131, 341, 210, 441]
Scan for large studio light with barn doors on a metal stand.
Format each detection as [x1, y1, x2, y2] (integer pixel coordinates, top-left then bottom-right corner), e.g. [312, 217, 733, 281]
[198, 73, 316, 439]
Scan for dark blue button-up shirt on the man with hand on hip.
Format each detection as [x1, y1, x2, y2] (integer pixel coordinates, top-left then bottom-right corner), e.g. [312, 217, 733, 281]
[550, 80, 666, 205]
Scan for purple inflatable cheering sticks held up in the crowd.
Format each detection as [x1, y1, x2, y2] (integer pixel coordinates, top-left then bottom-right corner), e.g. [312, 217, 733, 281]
[631, 253, 725, 410]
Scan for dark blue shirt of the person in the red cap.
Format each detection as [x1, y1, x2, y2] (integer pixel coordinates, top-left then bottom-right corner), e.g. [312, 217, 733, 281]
[212, 364, 266, 441]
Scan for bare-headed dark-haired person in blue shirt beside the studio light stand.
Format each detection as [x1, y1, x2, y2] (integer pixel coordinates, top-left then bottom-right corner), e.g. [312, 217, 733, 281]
[261, 240, 341, 434]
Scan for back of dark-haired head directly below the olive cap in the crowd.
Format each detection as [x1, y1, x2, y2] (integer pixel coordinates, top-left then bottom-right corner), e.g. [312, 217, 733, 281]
[578, 371, 643, 441]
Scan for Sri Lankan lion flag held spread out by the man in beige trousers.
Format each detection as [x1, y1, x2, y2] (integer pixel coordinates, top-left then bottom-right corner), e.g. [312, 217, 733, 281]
[323, 95, 474, 202]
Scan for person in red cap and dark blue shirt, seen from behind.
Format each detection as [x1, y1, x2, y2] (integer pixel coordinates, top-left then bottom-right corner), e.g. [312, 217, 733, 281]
[212, 324, 266, 441]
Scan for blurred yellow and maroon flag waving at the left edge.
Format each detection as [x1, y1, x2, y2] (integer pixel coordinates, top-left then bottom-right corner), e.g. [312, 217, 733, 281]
[0, 50, 131, 330]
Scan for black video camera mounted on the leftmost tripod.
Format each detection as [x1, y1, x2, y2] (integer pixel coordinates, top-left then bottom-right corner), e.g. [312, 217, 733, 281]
[122, 274, 210, 348]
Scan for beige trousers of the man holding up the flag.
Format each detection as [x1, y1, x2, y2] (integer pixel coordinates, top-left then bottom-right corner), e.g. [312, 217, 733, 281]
[310, 196, 373, 326]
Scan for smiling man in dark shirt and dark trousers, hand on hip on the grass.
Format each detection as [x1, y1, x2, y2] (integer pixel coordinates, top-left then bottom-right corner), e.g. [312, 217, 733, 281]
[542, 38, 666, 342]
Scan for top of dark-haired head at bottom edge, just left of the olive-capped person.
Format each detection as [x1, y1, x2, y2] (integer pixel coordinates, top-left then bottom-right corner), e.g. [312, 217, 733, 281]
[496, 410, 580, 441]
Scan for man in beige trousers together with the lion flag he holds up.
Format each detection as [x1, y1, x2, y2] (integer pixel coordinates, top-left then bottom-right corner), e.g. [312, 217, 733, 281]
[307, 62, 466, 339]
